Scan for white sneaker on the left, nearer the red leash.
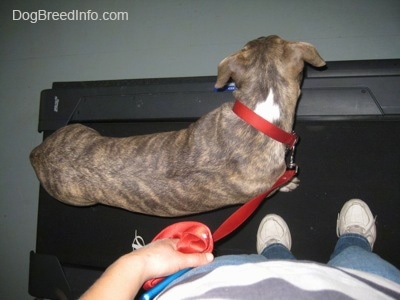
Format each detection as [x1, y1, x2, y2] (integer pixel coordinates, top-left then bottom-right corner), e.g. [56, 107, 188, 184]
[257, 214, 292, 254]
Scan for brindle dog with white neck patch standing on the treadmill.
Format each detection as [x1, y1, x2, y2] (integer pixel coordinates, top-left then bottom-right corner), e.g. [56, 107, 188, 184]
[30, 36, 325, 217]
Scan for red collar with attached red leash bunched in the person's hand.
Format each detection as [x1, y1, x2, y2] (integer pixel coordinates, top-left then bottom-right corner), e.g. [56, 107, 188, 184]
[143, 101, 297, 290]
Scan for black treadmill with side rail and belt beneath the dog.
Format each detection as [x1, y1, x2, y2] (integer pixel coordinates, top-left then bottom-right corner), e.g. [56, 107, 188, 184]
[29, 59, 400, 299]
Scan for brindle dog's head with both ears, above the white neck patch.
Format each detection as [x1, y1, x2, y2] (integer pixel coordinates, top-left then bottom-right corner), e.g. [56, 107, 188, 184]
[215, 35, 325, 108]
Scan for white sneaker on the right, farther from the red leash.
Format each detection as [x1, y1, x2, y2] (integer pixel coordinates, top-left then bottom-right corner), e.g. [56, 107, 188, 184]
[336, 199, 376, 249]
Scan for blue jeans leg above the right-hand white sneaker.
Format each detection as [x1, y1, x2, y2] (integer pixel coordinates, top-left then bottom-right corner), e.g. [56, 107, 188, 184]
[328, 233, 400, 283]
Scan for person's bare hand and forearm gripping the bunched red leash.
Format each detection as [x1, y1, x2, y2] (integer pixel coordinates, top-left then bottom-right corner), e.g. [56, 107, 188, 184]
[80, 238, 214, 300]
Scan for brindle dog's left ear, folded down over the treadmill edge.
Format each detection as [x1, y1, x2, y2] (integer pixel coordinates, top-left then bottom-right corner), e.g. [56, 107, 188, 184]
[214, 52, 243, 89]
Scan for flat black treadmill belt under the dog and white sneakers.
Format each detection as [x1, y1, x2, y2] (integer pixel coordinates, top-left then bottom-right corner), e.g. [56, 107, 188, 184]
[37, 121, 400, 268]
